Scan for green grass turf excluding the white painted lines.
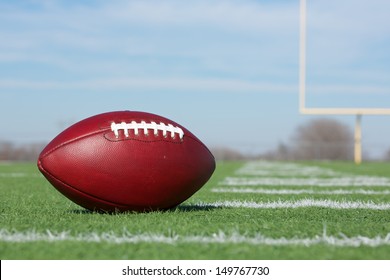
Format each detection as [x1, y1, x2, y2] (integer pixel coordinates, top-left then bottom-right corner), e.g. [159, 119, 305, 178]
[0, 162, 390, 259]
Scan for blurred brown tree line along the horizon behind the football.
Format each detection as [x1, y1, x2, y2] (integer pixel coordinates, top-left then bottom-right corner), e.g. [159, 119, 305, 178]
[0, 118, 390, 161]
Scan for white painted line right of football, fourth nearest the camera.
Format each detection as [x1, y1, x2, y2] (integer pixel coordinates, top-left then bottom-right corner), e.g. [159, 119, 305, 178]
[219, 176, 390, 187]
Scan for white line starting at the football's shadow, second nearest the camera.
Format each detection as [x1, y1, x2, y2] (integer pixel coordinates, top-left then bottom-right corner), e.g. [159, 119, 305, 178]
[192, 199, 390, 210]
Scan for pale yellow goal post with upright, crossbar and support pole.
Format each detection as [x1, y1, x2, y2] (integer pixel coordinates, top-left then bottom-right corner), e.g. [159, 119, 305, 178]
[299, 0, 390, 164]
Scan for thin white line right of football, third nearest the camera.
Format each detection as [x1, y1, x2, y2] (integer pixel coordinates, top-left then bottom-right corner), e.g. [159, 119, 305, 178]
[211, 188, 390, 195]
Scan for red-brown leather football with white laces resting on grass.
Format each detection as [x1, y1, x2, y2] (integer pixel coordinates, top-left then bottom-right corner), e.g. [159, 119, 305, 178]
[37, 111, 215, 212]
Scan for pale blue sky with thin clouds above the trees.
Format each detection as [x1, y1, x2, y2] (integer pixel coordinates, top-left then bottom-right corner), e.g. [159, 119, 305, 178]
[0, 0, 390, 157]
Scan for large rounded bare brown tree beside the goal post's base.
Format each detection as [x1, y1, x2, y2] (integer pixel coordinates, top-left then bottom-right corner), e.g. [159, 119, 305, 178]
[293, 118, 354, 160]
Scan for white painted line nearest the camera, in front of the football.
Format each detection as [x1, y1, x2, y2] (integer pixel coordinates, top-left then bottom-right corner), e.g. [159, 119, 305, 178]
[0, 230, 390, 247]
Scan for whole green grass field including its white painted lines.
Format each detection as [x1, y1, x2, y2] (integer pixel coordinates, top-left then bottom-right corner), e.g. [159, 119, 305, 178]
[0, 162, 390, 259]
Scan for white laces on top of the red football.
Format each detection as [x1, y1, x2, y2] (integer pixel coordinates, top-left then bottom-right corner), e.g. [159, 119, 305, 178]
[111, 121, 184, 139]
